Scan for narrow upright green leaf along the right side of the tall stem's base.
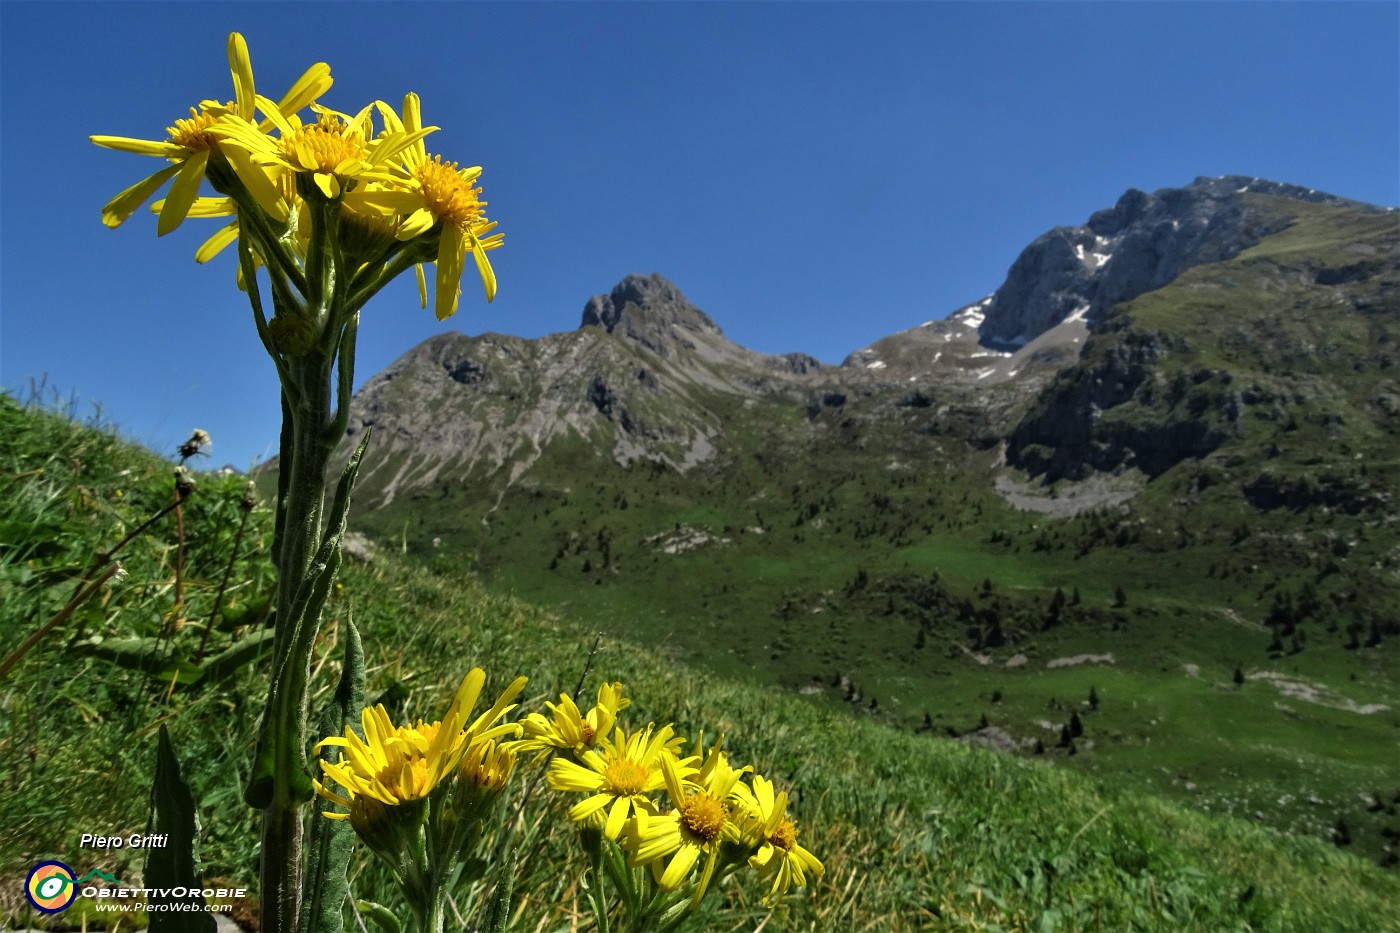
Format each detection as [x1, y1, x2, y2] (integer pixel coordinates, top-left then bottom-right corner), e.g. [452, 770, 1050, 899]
[298, 621, 364, 933]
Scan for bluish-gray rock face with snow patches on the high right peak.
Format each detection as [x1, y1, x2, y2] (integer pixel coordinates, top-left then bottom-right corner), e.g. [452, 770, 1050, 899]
[979, 175, 1379, 349]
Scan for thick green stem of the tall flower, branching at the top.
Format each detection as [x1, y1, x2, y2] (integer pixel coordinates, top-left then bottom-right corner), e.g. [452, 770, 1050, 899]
[220, 172, 375, 933]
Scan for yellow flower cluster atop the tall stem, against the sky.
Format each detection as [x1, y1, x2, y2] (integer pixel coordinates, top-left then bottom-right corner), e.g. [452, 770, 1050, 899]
[90, 32, 503, 319]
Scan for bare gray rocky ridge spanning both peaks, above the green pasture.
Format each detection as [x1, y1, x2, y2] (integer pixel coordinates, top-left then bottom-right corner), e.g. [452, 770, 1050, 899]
[324, 177, 1390, 504]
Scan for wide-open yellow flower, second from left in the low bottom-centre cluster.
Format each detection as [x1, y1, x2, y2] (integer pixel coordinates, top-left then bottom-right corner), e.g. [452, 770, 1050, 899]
[547, 723, 694, 839]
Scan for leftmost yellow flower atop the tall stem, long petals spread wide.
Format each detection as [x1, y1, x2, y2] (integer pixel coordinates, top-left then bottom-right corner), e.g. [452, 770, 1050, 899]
[88, 32, 332, 237]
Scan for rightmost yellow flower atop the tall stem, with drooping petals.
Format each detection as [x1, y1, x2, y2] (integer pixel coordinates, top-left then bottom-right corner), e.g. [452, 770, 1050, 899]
[346, 94, 505, 321]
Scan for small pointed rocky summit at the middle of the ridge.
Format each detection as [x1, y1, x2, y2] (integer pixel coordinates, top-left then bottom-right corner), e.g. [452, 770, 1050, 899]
[580, 273, 721, 356]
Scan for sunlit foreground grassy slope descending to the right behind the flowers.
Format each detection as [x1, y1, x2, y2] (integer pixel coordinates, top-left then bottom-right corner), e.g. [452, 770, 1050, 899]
[0, 398, 1400, 930]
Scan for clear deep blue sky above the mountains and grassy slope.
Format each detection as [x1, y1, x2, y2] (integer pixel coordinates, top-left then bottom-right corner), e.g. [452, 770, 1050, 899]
[0, 1, 1400, 468]
